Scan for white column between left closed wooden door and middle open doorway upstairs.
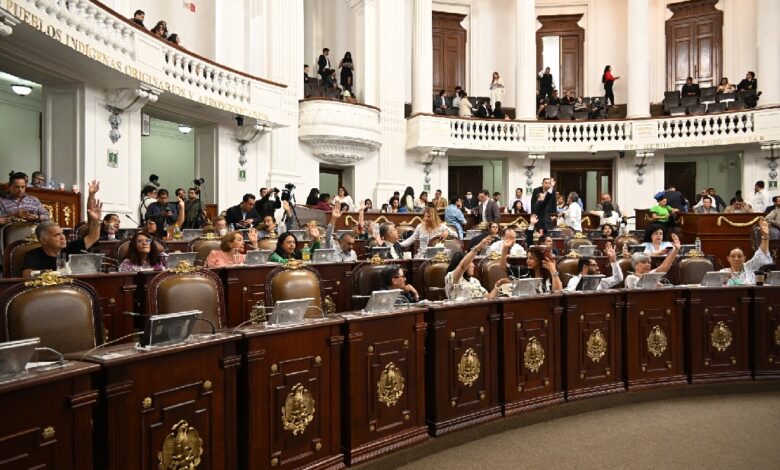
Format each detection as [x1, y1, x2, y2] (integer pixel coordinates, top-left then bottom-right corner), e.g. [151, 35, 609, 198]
[514, 0, 537, 119]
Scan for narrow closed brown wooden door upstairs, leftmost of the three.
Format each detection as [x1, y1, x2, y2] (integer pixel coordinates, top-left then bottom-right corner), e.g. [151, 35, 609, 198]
[432, 11, 469, 94]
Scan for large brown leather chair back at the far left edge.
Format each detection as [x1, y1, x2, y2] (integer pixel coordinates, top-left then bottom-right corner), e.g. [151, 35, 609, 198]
[0, 273, 103, 354]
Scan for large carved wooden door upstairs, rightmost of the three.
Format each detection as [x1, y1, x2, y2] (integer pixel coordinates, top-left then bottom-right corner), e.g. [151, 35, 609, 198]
[666, 0, 723, 90]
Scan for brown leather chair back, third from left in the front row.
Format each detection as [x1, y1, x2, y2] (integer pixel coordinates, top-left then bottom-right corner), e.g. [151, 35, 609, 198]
[265, 262, 323, 318]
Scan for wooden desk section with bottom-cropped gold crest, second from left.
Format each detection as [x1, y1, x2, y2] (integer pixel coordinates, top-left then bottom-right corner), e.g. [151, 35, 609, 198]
[85, 333, 241, 470]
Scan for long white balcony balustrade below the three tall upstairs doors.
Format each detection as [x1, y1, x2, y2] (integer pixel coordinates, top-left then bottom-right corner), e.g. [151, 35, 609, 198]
[407, 107, 780, 152]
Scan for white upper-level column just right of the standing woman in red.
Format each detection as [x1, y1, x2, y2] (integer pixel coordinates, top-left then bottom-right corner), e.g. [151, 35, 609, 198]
[627, 0, 650, 119]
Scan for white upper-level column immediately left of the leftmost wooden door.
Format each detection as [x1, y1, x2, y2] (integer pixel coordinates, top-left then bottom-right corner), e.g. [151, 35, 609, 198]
[412, 0, 433, 114]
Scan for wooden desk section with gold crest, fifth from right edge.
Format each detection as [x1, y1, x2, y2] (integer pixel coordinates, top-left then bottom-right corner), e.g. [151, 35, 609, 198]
[498, 294, 564, 416]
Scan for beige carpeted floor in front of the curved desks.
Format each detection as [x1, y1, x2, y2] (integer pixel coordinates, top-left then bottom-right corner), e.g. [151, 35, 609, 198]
[361, 390, 780, 470]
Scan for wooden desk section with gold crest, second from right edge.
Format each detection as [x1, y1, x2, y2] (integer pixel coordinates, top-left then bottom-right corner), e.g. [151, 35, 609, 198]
[685, 287, 752, 383]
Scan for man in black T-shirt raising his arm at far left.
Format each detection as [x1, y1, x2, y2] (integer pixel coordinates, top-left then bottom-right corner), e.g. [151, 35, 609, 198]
[22, 181, 103, 278]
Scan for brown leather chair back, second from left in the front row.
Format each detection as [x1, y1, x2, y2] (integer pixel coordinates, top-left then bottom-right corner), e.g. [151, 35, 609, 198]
[146, 266, 227, 333]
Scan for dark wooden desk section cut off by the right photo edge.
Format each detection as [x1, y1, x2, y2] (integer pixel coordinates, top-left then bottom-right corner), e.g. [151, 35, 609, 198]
[751, 286, 780, 380]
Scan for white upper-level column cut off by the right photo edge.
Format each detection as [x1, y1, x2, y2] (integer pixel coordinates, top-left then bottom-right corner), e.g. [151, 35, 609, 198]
[756, 0, 780, 106]
